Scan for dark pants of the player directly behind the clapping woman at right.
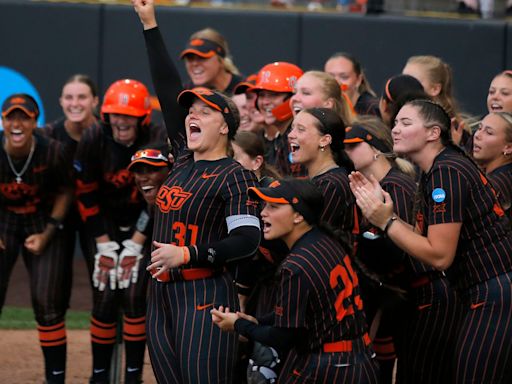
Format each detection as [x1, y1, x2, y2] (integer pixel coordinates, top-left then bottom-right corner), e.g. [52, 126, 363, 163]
[395, 277, 461, 384]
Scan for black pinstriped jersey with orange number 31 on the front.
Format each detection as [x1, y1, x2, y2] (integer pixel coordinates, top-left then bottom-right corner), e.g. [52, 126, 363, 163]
[153, 150, 257, 262]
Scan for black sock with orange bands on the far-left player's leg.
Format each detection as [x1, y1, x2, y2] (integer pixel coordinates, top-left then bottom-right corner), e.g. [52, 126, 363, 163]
[37, 321, 67, 383]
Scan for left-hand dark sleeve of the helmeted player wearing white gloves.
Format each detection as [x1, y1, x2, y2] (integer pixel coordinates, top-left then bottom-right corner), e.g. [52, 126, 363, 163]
[73, 127, 107, 237]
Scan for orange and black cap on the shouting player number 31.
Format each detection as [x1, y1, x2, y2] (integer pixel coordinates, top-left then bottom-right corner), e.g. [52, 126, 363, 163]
[178, 87, 238, 139]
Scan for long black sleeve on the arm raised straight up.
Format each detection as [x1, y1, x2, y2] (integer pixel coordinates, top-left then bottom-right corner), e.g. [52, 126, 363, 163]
[144, 27, 187, 158]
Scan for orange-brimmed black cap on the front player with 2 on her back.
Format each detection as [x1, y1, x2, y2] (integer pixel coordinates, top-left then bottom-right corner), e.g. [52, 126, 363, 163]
[248, 179, 320, 225]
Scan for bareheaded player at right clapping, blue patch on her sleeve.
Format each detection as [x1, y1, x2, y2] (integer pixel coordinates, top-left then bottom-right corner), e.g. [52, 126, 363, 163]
[351, 100, 512, 383]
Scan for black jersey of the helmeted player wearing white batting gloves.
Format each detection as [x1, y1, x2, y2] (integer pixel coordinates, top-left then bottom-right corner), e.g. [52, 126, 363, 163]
[74, 124, 165, 237]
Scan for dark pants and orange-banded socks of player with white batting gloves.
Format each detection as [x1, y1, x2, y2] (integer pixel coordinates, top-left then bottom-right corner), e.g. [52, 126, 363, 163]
[86, 220, 150, 383]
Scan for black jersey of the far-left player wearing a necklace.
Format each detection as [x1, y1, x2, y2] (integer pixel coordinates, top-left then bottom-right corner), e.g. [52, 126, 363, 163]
[0, 132, 73, 220]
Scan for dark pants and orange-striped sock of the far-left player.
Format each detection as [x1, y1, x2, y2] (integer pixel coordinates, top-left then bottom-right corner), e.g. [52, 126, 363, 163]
[0, 212, 74, 382]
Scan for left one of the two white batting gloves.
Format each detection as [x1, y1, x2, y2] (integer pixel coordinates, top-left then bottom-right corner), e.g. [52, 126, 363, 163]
[92, 241, 119, 291]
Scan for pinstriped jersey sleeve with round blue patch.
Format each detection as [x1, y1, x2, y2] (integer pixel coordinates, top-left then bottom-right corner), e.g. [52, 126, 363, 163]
[425, 166, 469, 225]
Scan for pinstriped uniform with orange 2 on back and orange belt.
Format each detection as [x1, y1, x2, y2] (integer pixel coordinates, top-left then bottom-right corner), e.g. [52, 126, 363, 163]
[235, 229, 378, 383]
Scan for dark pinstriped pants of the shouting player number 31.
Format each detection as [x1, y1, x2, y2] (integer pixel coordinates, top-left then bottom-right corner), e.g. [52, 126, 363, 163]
[147, 272, 238, 384]
